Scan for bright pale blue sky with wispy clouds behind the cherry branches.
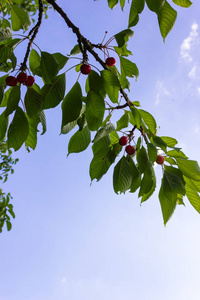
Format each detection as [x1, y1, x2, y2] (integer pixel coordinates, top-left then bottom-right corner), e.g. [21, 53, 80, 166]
[0, 0, 200, 300]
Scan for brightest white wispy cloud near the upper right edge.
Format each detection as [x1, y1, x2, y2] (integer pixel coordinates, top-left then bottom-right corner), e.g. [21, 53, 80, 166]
[180, 23, 199, 62]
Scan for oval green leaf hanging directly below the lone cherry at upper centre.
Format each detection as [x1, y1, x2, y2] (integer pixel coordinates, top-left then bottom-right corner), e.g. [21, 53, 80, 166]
[86, 90, 105, 131]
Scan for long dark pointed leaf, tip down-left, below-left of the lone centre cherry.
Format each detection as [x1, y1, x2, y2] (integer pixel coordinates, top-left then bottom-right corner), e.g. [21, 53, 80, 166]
[61, 82, 82, 132]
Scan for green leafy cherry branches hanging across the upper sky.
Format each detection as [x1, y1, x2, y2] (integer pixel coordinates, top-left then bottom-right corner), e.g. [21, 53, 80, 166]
[0, 0, 200, 227]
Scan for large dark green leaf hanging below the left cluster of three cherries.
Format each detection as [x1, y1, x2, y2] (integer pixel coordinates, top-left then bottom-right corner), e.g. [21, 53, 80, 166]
[7, 107, 29, 151]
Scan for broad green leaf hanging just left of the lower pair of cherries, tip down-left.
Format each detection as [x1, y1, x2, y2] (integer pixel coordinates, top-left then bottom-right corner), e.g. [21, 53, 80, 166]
[90, 147, 112, 181]
